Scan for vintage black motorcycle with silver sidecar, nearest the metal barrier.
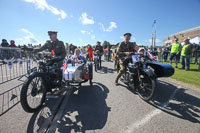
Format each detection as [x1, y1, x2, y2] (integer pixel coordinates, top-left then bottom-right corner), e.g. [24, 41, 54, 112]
[20, 51, 93, 113]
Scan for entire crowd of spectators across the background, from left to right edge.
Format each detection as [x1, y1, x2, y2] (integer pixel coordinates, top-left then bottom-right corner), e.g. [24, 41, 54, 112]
[0, 34, 200, 71]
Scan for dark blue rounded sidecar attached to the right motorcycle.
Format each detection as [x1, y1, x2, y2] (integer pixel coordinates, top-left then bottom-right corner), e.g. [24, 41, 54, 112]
[147, 62, 174, 78]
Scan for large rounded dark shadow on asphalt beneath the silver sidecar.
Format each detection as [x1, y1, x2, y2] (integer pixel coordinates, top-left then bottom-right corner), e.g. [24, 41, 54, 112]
[54, 83, 110, 133]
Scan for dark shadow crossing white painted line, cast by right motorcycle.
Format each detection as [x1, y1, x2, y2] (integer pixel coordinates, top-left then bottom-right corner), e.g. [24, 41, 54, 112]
[150, 81, 200, 123]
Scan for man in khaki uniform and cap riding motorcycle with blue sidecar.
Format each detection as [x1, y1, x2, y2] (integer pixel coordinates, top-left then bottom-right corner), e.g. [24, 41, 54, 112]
[115, 33, 137, 85]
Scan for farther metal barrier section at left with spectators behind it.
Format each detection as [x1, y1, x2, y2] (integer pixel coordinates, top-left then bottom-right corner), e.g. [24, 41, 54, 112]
[0, 48, 37, 84]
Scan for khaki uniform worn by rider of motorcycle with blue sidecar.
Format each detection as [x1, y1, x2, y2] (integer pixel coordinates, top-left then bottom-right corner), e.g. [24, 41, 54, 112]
[116, 42, 136, 81]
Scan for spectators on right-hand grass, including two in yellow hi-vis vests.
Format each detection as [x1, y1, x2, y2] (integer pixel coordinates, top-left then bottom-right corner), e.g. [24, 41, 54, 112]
[149, 38, 200, 71]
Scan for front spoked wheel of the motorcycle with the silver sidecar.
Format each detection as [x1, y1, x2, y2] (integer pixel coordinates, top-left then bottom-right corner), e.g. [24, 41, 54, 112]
[20, 73, 46, 113]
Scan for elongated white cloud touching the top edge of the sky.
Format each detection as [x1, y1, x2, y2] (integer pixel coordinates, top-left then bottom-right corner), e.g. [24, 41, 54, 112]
[24, 0, 67, 20]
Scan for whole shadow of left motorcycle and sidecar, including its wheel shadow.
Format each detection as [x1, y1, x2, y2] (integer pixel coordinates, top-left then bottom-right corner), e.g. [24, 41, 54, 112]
[27, 83, 110, 133]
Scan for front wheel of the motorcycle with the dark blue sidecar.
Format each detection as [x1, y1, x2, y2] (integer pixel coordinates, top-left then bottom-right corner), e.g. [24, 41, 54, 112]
[137, 75, 156, 101]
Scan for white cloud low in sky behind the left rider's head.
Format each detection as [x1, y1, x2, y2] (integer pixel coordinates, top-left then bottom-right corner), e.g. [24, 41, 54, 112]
[16, 28, 41, 44]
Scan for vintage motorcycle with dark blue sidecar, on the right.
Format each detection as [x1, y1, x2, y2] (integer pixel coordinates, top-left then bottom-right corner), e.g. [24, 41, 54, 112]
[117, 53, 174, 101]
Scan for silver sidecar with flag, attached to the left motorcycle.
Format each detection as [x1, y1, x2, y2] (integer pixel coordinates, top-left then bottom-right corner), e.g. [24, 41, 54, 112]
[63, 62, 93, 86]
